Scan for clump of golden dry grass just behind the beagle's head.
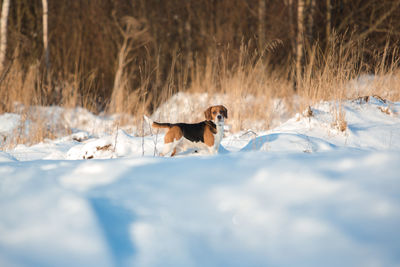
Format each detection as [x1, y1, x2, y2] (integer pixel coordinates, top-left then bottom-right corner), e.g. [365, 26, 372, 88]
[188, 46, 293, 131]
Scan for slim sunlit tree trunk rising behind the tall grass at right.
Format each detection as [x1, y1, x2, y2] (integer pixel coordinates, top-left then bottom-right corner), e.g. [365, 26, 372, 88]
[295, 0, 304, 90]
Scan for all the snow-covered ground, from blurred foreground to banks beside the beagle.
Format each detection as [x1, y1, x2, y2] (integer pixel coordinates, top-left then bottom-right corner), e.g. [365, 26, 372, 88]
[0, 97, 400, 266]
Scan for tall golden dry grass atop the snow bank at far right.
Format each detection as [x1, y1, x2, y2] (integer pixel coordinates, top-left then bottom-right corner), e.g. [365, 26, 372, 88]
[298, 33, 400, 131]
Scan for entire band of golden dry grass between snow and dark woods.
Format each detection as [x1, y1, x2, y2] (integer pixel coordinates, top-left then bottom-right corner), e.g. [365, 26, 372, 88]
[0, 37, 400, 148]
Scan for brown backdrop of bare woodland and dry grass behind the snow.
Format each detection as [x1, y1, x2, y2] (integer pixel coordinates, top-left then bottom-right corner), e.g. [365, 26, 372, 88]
[0, 0, 400, 144]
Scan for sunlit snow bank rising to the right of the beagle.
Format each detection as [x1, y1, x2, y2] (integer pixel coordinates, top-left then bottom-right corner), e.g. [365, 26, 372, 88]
[222, 97, 400, 152]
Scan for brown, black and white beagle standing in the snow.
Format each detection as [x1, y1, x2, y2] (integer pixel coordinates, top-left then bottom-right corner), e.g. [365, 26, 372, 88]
[152, 105, 228, 157]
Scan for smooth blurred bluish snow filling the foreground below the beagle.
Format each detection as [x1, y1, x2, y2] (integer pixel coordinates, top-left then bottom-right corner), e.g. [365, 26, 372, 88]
[0, 151, 400, 267]
